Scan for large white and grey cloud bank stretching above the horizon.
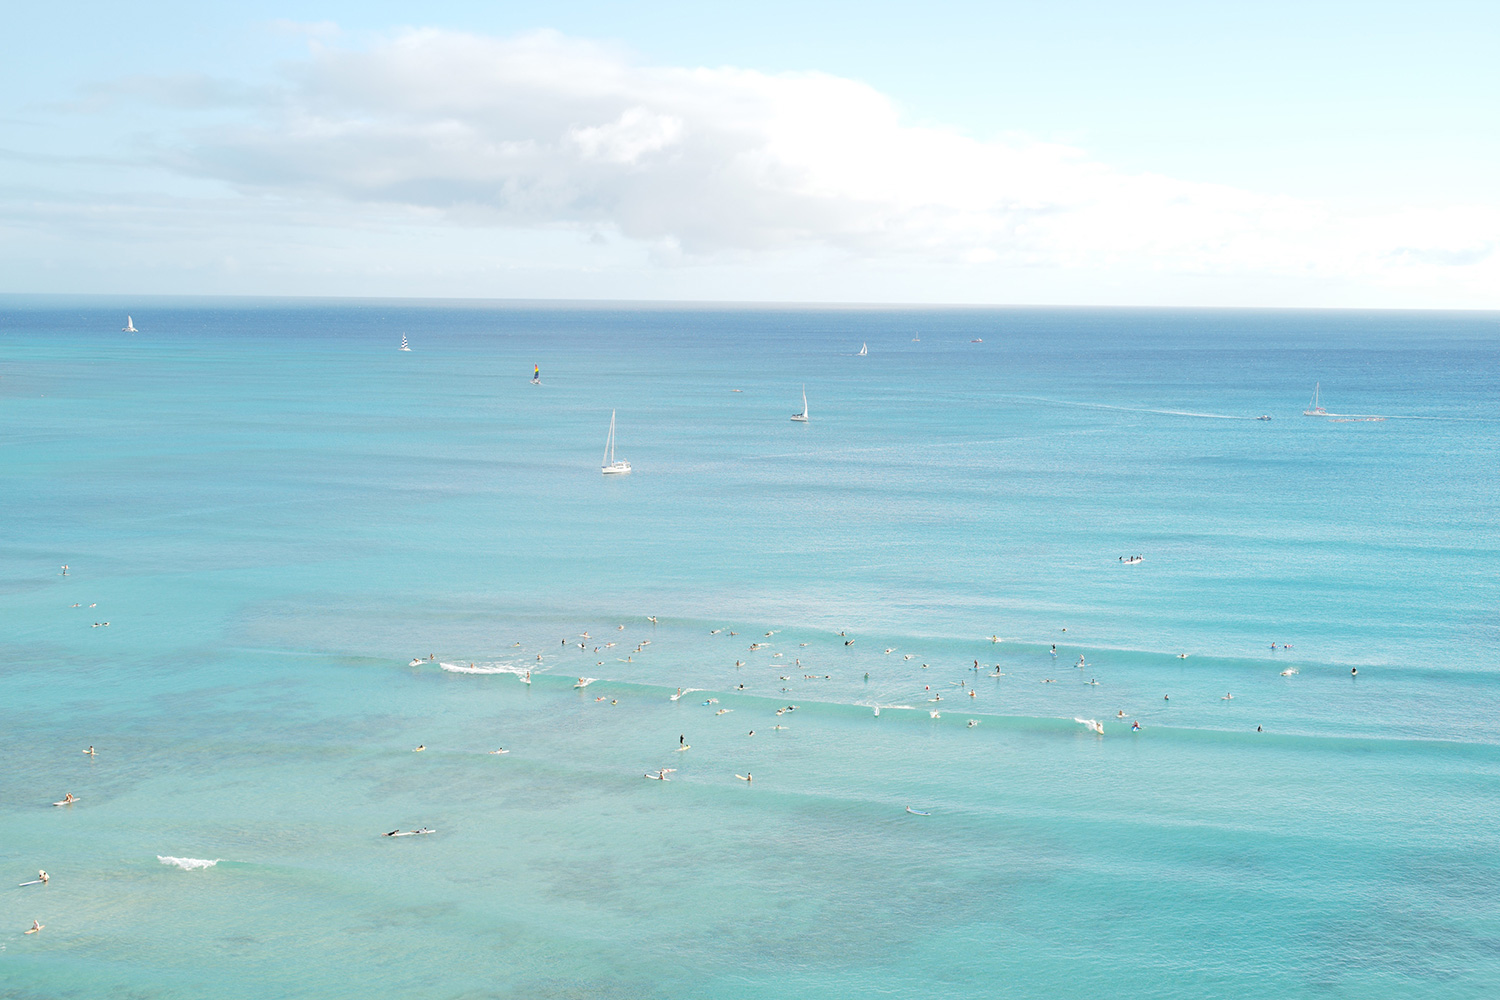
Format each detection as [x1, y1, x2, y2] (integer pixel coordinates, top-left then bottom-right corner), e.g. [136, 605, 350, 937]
[35, 25, 1500, 304]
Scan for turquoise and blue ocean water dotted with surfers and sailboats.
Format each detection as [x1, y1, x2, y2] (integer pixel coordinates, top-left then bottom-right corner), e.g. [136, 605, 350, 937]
[0, 300, 1500, 997]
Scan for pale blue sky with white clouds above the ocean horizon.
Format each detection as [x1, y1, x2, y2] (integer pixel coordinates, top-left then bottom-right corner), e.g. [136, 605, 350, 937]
[0, 0, 1500, 309]
